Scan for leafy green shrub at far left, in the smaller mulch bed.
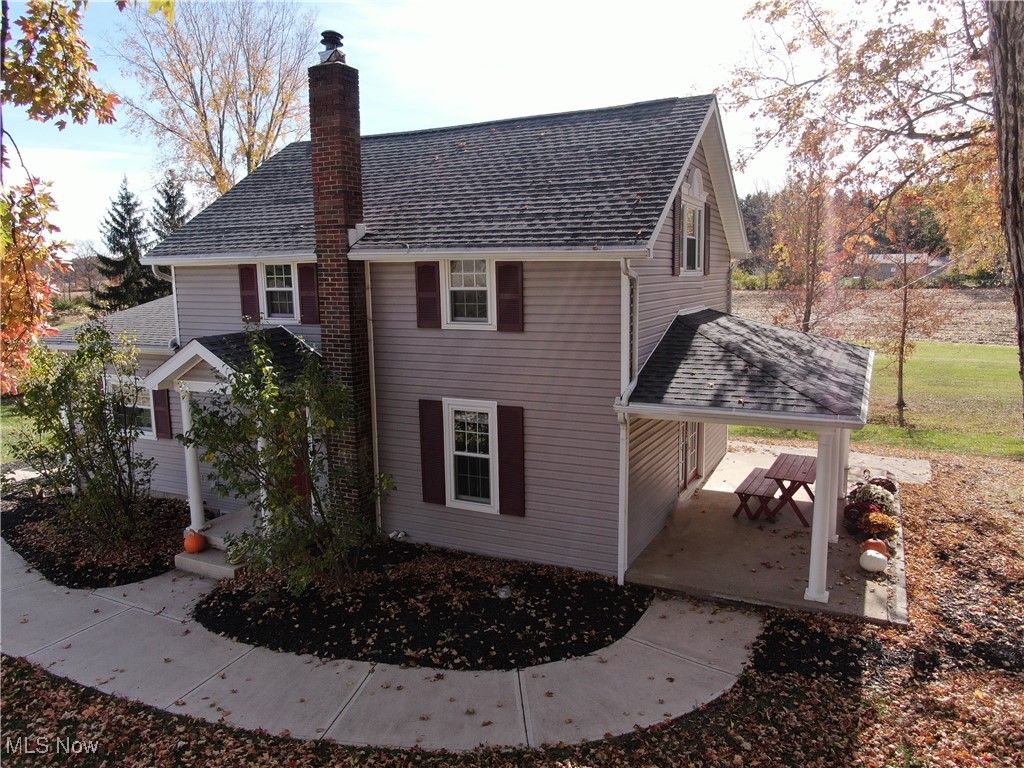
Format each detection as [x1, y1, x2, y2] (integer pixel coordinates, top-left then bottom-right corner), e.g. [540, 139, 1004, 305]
[14, 323, 155, 546]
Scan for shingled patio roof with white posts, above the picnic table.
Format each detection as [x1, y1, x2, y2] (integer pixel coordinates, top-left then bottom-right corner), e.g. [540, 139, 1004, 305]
[615, 309, 874, 602]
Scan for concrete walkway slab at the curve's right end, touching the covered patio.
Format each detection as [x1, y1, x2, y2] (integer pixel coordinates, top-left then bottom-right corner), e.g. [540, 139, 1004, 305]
[626, 599, 762, 675]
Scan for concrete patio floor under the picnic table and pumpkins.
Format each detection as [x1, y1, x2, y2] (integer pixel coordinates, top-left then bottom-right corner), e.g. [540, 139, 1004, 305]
[626, 443, 930, 625]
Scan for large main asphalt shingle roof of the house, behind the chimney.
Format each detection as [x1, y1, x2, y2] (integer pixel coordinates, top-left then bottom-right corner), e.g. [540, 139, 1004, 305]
[146, 95, 714, 261]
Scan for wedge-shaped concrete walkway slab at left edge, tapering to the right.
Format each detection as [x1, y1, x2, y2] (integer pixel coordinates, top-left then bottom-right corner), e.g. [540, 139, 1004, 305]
[0, 581, 128, 656]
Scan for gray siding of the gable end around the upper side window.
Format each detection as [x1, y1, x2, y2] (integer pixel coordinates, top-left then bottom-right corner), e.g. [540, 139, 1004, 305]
[630, 146, 730, 367]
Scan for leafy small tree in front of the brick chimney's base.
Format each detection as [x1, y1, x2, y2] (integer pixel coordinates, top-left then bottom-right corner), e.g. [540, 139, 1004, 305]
[184, 330, 390, 593]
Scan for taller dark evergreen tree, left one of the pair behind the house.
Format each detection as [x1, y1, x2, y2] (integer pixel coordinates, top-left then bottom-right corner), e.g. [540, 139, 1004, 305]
[93, 178, 171, 311]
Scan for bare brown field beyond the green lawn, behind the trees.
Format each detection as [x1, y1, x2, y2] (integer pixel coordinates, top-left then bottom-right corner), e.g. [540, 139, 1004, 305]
[732, 288, 1017, 345]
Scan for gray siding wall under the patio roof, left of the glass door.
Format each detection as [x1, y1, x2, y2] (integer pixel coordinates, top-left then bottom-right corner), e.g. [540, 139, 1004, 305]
[628, 419, 679, 562]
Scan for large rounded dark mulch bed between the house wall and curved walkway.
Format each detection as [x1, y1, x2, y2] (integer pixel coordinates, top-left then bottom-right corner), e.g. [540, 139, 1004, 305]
[195, 542, 652, 670]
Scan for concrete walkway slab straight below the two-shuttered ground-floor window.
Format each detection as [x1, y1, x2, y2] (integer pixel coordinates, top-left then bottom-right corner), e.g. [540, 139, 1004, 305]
[327, 665, 526, 751]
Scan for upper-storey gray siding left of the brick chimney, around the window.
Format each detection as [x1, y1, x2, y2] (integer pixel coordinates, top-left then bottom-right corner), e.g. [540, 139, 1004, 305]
[174, 264, 321, 349]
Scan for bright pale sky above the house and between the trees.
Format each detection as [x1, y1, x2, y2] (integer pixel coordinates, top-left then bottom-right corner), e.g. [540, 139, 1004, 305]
[3, 0, 785, 244]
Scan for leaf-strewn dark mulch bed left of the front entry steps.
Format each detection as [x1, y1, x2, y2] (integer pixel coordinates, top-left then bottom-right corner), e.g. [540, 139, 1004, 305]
[0, 483, 188, 589]
